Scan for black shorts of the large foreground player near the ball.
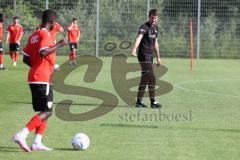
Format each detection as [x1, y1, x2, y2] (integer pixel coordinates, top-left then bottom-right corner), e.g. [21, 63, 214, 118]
[29, 84, 53, 112]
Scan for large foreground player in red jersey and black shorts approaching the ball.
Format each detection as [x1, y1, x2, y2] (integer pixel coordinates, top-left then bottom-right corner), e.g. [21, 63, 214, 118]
[13, 10, 68, 152]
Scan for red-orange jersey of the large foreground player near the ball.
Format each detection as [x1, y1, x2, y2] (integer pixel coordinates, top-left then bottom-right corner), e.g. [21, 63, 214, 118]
[23, 28, 56, 84]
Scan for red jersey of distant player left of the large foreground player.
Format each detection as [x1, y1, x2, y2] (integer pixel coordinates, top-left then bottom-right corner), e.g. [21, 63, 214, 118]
[7, 24, 24, 43]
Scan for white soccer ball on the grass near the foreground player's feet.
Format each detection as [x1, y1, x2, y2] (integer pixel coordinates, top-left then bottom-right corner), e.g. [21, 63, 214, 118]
[72, 133, 90, 150]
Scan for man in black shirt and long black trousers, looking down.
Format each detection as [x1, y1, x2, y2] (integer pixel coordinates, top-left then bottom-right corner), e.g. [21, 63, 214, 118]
[131, 9, 161, 108]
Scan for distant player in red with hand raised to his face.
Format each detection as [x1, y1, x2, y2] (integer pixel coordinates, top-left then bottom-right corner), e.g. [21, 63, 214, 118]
[68, 18, 80, 65]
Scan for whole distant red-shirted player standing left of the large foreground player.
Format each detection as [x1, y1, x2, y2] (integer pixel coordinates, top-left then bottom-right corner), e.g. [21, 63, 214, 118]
[6, 17, 24, 66]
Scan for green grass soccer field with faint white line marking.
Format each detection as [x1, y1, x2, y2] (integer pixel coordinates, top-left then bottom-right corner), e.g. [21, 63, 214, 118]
[0, 57, 240, 160]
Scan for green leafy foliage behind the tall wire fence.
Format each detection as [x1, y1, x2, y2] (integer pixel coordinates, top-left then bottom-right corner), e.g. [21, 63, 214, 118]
[0, 0, 240, 58]
